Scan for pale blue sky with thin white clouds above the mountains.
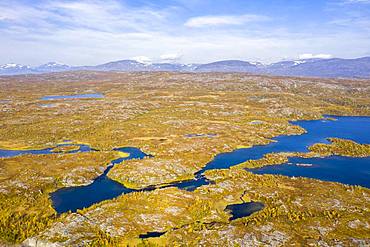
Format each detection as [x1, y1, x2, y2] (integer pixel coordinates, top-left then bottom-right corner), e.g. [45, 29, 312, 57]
[0, 0, 370, 65]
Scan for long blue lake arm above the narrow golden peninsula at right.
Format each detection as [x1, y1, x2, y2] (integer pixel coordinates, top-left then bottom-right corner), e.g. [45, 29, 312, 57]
[198, 117, 370, 174]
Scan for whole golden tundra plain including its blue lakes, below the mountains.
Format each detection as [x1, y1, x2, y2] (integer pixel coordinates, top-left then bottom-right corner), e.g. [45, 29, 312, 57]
[0, 71, 370, 246]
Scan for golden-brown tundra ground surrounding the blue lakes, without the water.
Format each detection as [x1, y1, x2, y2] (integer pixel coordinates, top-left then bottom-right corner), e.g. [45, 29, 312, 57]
[0, 72, 370, 246]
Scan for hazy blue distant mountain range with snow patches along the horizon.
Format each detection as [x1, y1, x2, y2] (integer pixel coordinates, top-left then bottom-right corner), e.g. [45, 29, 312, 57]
[0, 57, 370, 78]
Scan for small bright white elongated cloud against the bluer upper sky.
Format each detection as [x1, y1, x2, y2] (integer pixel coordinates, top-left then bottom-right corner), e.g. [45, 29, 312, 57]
[184, 15, 269, 27]
